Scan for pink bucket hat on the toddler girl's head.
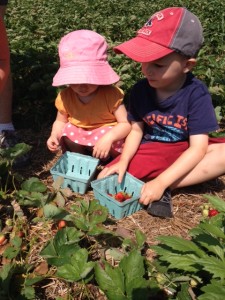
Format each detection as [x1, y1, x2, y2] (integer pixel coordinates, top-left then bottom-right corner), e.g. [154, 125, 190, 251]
[52, 29, 120, 86]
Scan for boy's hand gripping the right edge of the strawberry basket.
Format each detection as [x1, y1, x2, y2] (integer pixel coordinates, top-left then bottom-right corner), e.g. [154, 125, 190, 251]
[139, 179, 167, 205]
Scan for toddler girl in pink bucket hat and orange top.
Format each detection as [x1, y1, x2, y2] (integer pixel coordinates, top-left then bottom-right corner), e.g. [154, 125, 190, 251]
[47, 30, 131, 160]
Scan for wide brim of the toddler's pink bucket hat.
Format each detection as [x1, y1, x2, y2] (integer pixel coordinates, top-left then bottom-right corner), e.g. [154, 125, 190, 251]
[52, 62, 120, 86]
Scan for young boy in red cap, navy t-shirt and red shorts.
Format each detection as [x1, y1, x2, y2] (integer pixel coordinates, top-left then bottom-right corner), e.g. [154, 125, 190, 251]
[98, 7, 225, 217]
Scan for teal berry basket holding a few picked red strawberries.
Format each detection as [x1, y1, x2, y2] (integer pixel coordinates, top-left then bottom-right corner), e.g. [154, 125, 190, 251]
[91, 172, 144, 219]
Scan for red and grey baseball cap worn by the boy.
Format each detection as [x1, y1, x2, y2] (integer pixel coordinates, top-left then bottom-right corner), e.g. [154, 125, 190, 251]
[114, 7, 203, 62]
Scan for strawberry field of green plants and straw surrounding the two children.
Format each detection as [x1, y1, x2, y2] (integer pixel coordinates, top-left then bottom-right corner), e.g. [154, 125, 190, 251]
[0, 0, 225, 300]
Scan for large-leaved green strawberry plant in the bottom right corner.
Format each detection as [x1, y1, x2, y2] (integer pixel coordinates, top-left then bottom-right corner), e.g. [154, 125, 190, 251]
[152, 195, 225, 300]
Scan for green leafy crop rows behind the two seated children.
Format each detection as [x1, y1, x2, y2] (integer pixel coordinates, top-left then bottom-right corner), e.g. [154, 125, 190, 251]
[6, 0, 225, 129]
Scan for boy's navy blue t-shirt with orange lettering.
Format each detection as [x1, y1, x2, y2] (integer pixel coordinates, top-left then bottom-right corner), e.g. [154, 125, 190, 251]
[128, 73, 219, 143]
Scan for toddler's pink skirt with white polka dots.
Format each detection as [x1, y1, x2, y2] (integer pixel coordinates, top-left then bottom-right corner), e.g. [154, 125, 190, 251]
[62, 123, 124, 153]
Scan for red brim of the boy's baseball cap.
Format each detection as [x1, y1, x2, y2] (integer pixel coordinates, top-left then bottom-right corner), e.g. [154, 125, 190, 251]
[114, 36, 174, 62]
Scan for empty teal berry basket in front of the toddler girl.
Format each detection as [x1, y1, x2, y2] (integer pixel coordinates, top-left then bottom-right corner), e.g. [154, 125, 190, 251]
[50, 151, 99, 194]
